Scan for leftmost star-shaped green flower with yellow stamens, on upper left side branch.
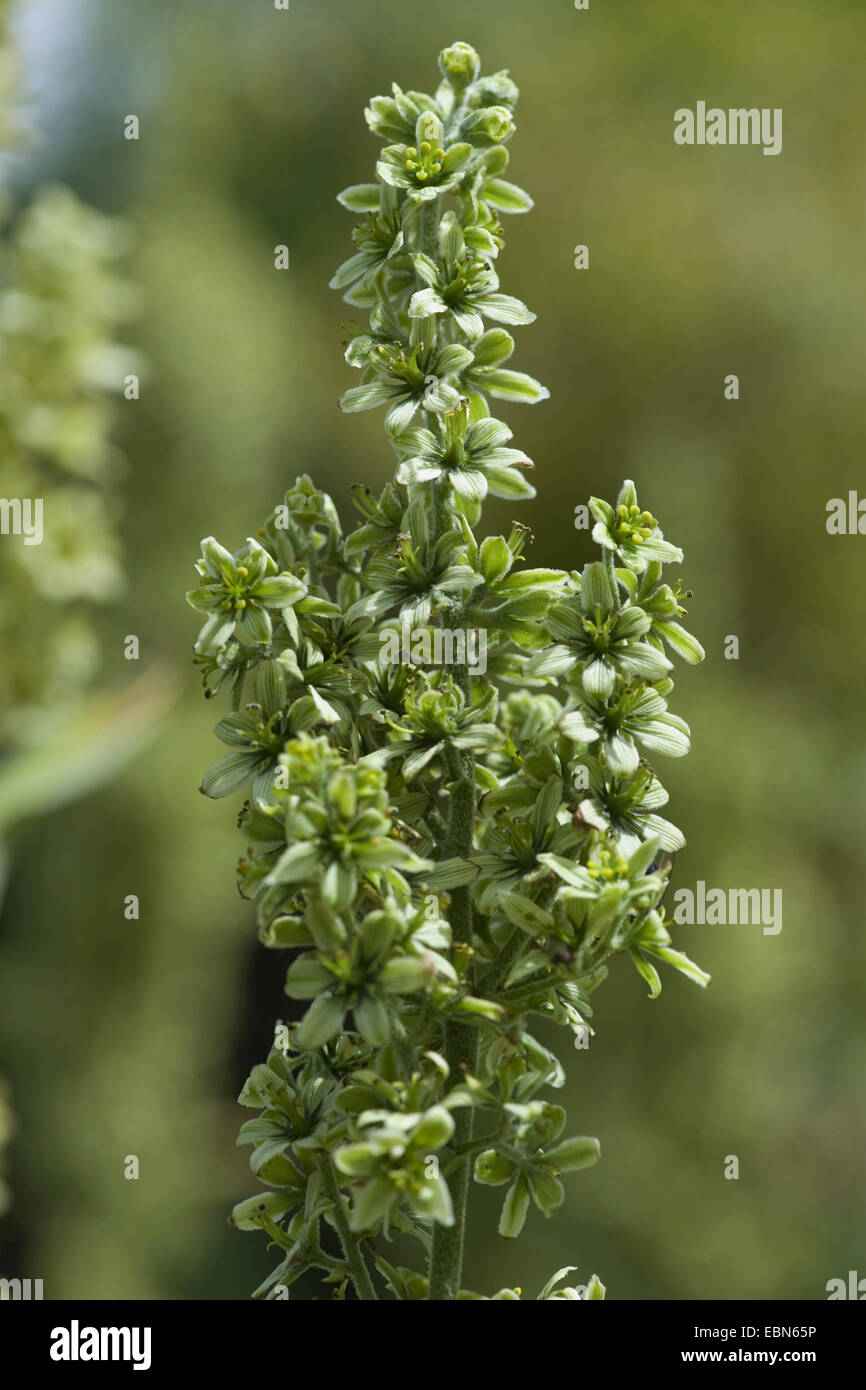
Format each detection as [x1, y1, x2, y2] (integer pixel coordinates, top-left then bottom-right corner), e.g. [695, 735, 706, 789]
[186, 535, 307, 656]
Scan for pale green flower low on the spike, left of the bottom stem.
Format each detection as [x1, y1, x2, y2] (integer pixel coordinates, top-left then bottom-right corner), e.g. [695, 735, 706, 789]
[334, 1105, 455, 1233]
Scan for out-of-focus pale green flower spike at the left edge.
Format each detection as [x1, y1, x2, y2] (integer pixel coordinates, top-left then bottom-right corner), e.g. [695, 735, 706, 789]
[0, 186, 133, 744]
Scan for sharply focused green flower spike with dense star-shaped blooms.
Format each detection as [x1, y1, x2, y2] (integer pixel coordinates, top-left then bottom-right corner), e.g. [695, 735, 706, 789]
[189, 43, 708, 1300]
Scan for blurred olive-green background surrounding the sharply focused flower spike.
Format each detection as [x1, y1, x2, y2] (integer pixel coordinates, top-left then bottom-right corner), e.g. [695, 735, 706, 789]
[0, 0, 866, 1300]
